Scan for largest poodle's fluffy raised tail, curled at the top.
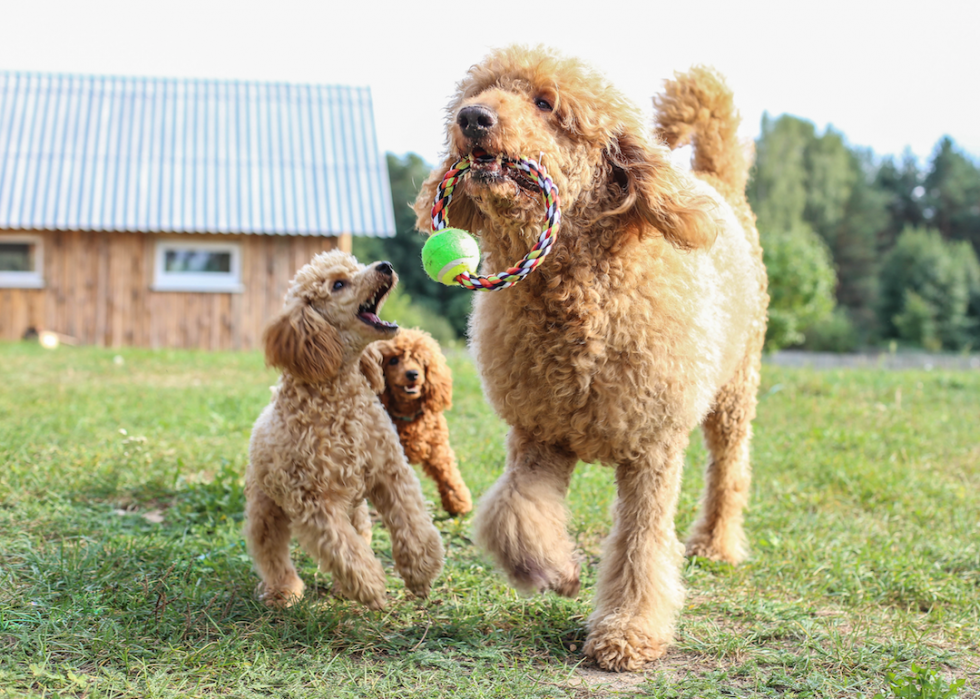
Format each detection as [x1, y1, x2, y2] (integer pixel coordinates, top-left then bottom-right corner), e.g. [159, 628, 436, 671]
[653, 66, 752, 197]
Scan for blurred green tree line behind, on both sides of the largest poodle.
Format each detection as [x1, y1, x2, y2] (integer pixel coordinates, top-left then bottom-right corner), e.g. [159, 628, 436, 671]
[354, 122, 980, 351]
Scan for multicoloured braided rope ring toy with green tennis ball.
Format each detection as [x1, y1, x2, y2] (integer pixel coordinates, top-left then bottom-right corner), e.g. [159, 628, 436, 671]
[422, 151, 561, 291]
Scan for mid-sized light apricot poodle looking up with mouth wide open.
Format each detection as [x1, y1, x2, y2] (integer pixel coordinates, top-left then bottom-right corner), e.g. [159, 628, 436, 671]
[245, 250, 443, 608]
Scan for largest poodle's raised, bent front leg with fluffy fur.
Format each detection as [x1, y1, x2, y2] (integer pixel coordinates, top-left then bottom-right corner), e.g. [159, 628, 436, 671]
[475, 427, 579, 597]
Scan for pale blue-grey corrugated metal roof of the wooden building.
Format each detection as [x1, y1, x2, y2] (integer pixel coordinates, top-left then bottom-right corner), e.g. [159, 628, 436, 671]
[0, 71, 395, 237]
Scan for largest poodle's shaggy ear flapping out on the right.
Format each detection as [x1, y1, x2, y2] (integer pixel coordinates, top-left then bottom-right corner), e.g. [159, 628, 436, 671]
[599, 133, 717, 249]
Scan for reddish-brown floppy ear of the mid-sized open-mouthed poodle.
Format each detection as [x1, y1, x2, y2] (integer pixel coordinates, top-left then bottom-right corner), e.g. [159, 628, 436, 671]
[262, 300, 344, 383]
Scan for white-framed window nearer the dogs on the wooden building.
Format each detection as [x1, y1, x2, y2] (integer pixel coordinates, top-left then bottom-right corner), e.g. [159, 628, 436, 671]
[153, 240, 242, 292]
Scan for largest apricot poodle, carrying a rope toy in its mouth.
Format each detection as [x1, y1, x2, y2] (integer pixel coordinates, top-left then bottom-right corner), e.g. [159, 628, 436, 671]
[416, 47, 768, 670]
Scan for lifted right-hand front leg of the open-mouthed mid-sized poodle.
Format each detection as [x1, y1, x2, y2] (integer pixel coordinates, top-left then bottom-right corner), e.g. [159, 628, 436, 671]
[367, 456, 444, 597]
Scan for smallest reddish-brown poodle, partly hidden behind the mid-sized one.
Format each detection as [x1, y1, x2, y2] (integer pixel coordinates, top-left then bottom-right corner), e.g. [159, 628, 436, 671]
[371, 330, 473, 515]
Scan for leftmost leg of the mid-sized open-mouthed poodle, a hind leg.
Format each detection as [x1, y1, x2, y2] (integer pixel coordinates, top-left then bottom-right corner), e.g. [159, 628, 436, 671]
[245, 488, 303, 607]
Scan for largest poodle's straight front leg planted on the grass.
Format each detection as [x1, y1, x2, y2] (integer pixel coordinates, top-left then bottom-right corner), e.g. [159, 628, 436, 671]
[585, 434, 687, 671]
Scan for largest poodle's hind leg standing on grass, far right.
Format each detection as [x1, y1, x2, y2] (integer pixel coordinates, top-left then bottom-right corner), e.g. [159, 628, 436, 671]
[687, 353, 759, 563]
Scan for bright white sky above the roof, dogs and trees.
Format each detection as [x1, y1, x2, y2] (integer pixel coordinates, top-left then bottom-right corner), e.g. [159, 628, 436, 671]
[0, 0, 980, 163]
